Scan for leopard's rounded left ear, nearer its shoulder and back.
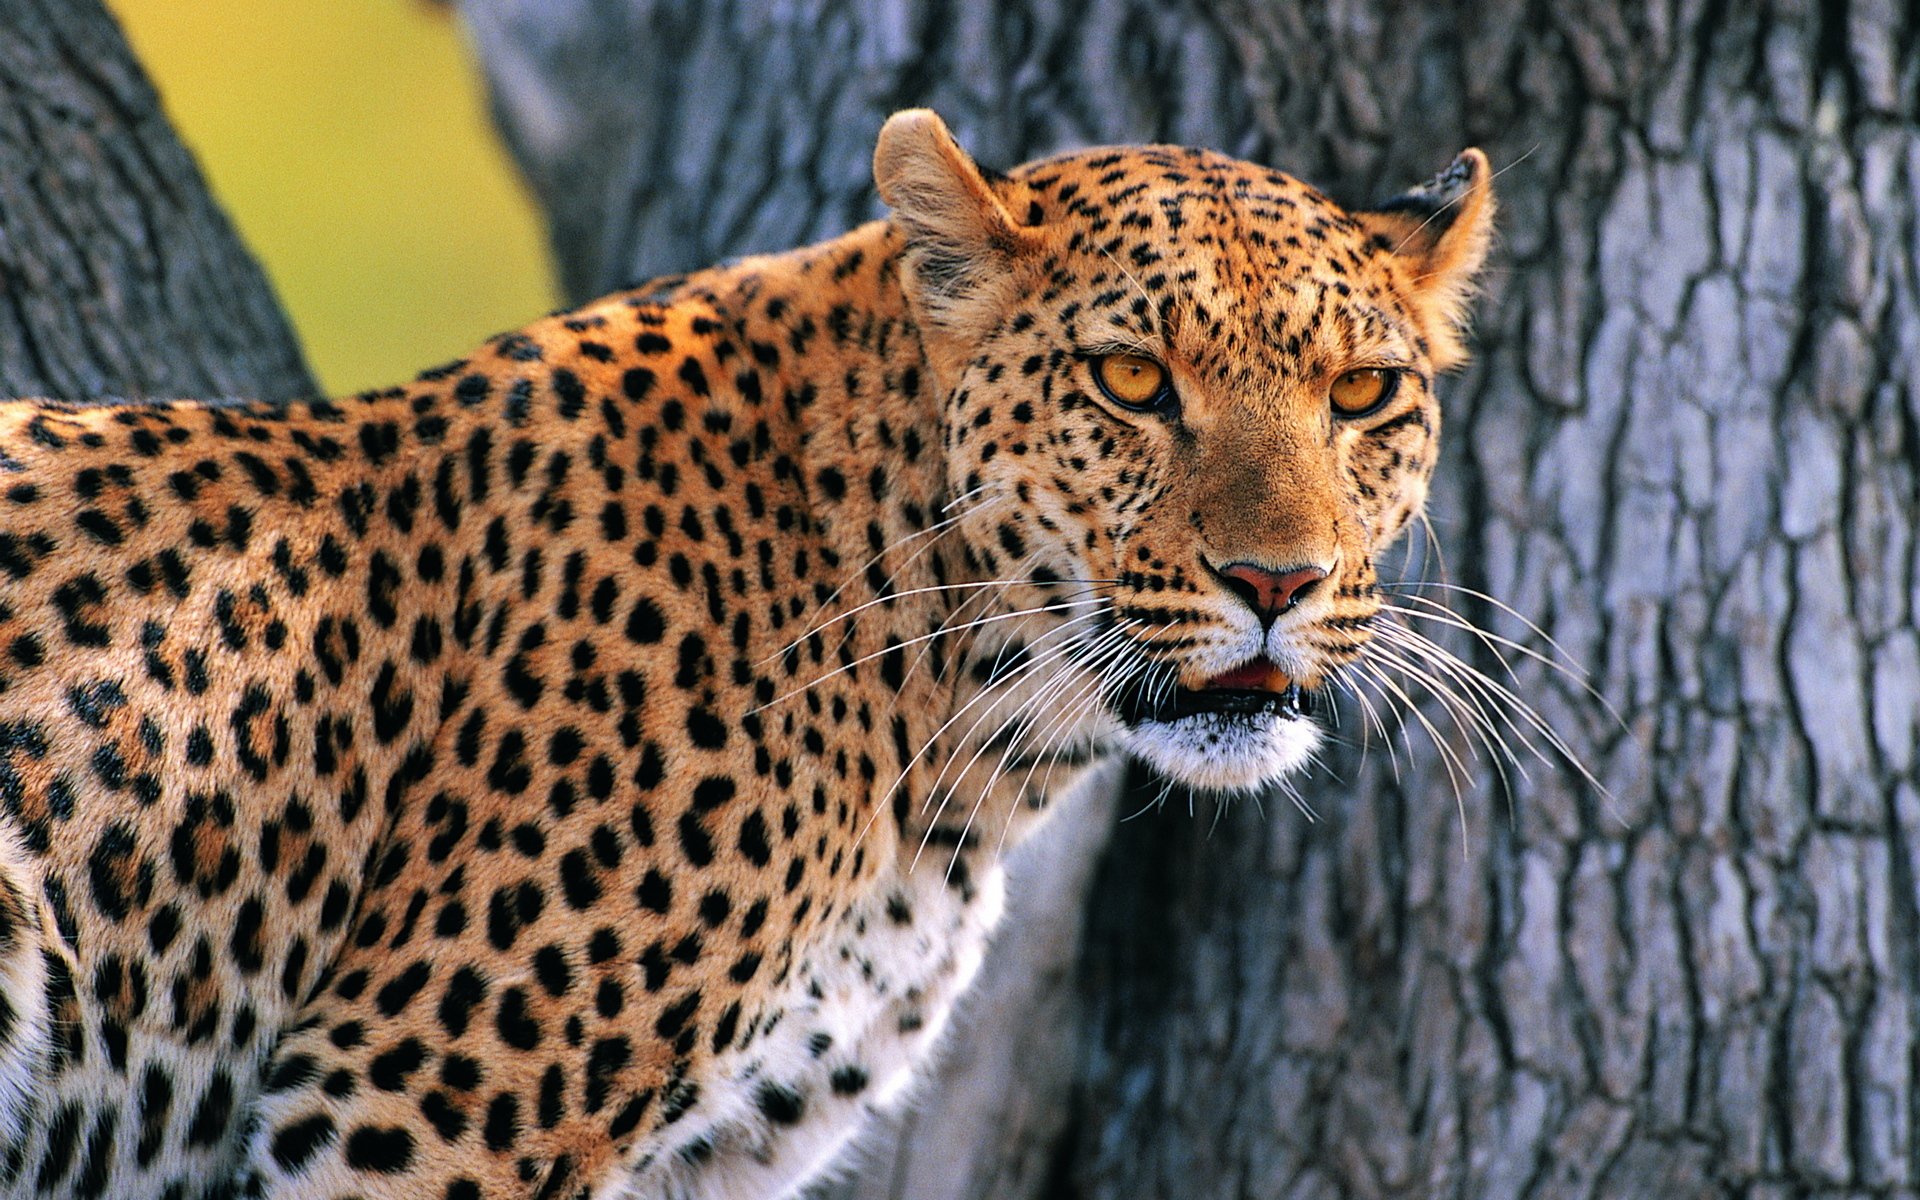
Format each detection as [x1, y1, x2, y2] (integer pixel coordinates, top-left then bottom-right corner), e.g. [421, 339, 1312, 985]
[874, 108, 1033, 332]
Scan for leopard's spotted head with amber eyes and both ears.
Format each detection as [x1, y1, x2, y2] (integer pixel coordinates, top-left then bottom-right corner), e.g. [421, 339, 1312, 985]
[876, 111, 1494, 789]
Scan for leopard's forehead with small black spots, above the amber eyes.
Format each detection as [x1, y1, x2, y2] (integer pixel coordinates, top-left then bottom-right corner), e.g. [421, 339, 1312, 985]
[1008, 146, 1419, 384]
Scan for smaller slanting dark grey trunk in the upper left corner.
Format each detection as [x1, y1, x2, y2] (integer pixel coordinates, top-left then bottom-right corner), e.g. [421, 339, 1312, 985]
[0, 0, 315, 399]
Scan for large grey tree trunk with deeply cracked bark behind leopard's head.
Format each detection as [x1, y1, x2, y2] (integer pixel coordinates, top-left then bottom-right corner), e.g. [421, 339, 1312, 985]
[463, 0, 1920, 1200]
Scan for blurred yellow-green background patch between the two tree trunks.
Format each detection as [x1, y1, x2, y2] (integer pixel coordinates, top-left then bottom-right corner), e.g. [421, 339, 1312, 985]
[108, 0, 555, 394]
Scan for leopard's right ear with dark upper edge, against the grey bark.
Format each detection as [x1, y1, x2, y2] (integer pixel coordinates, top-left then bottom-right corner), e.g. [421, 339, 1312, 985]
[1354, 150, 1494, 371]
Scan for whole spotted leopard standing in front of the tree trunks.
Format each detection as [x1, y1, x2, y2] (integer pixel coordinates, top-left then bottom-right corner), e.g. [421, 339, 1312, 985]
[0, 109, 1494, 1200]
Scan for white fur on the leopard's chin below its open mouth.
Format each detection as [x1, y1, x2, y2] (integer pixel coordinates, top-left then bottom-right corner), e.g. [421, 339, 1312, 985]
[1127, 712, 1321, 791]
